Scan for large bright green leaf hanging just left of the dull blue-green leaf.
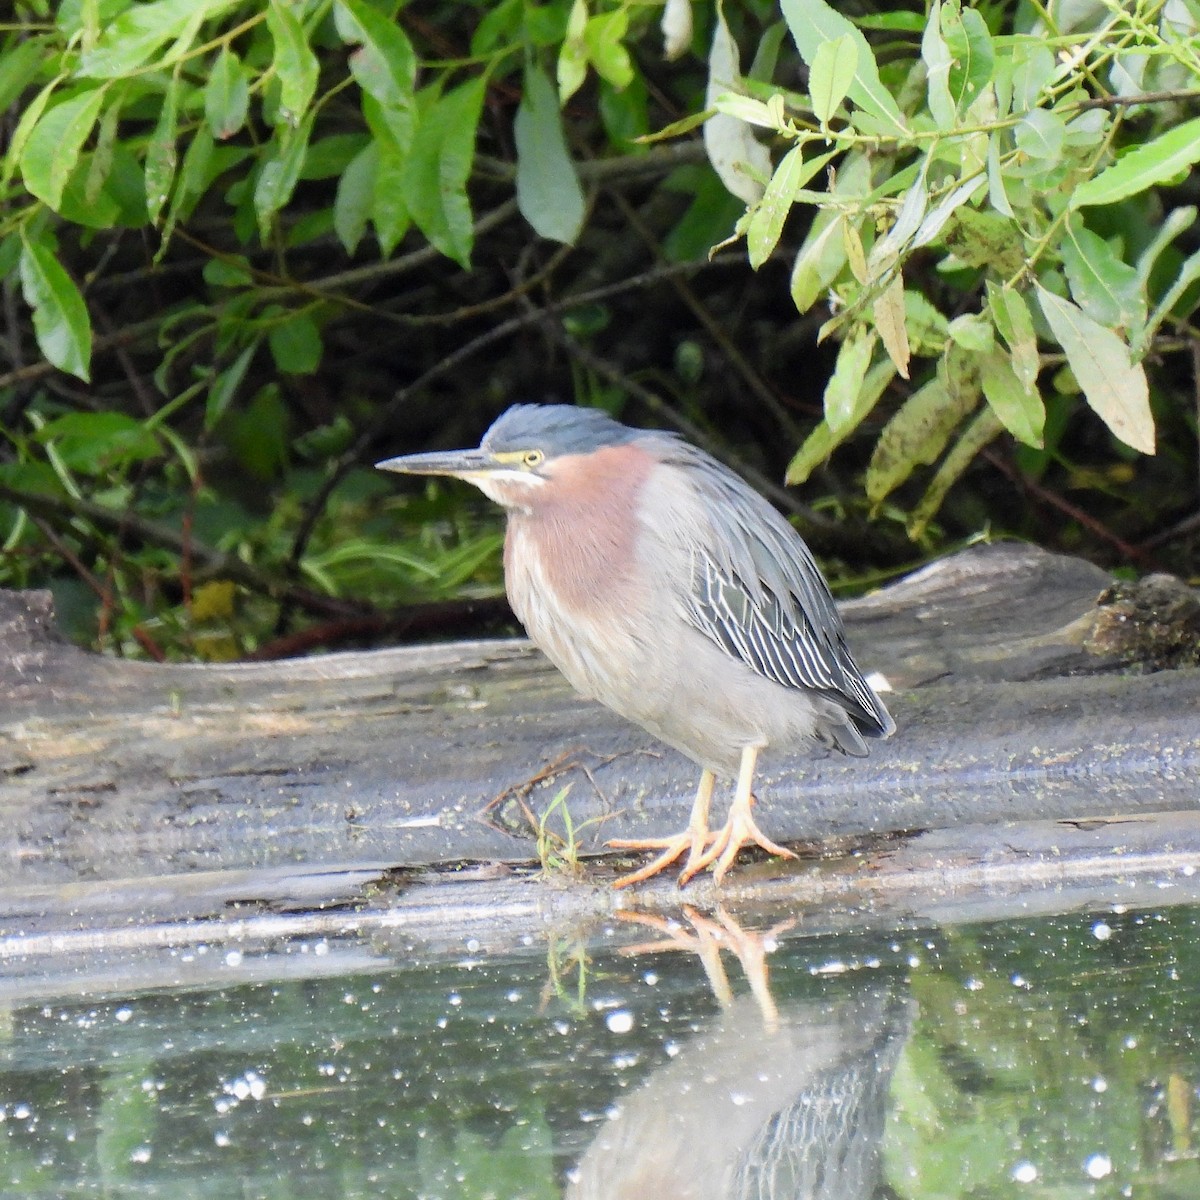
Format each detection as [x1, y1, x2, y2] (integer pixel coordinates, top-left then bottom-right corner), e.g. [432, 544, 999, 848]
[403, 76, 487, 266]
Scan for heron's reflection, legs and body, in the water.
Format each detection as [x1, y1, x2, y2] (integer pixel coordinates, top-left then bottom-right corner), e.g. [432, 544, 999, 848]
[566, 911, 914, 1200]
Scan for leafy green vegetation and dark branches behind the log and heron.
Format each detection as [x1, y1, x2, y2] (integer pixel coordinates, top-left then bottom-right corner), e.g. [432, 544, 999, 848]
[0, 0, 1200, 658]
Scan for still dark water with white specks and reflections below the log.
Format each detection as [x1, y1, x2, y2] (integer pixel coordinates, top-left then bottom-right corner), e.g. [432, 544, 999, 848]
[0, 906, 1200, 1200]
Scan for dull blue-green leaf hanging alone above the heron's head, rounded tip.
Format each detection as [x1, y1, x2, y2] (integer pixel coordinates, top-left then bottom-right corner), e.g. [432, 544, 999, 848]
[514, 67, 584, 246]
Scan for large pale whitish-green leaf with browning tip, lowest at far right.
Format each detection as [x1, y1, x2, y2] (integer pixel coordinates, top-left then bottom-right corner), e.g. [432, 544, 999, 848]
[1037, 283, 1154, 454]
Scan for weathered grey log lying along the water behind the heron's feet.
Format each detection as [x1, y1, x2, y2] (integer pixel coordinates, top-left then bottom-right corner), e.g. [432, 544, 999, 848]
[0, 545, 1200, 936]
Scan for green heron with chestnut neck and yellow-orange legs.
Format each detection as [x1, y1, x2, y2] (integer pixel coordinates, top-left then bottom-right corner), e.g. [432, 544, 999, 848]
[379, 404, 895, 887]
